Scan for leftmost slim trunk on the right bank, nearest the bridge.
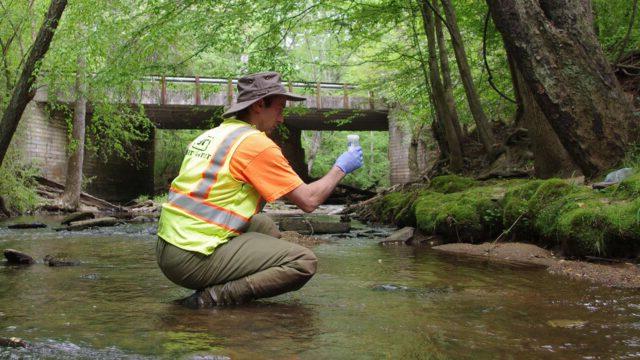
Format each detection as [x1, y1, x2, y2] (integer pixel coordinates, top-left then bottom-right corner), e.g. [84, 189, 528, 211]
[420, 0, 463, 172]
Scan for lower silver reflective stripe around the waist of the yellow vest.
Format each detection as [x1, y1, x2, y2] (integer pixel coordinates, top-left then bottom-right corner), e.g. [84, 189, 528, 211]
[169, 191, 249, 232]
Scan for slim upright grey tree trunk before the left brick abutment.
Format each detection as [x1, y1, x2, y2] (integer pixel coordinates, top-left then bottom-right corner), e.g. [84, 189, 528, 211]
[62, 53, 87, 211]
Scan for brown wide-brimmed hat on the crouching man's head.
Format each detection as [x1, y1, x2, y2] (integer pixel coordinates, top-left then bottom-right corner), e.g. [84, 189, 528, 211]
[222, 71, 307, 118]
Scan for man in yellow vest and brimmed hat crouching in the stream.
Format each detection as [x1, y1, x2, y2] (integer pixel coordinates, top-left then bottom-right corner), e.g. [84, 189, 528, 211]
[156, 72, 362, 308]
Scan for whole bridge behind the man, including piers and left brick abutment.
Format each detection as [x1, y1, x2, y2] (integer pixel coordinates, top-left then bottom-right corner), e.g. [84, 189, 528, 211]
[20, 76, 410, 201]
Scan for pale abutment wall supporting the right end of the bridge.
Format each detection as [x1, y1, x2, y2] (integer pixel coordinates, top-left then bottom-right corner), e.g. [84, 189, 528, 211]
[389, 103, 411, 185]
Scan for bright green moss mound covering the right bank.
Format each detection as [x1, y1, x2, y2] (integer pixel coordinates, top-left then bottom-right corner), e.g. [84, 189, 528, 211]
[368, 174, 640, 257]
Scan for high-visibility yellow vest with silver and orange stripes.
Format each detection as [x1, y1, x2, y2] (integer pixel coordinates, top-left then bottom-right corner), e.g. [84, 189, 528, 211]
[158, 118, 264, 255]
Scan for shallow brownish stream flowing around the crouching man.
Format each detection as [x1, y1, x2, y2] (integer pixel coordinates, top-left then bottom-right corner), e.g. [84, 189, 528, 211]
[0, 218, 640, 359]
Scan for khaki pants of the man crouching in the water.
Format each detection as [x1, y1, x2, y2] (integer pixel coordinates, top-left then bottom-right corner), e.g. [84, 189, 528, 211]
[156, 214, 317, 304]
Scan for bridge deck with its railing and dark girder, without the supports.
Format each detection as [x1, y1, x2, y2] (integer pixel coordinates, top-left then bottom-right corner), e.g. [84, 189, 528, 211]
[36, 77, 388, 131]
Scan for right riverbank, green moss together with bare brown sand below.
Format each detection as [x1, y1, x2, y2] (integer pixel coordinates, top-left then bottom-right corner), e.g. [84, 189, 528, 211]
[355, 174, 640, 288]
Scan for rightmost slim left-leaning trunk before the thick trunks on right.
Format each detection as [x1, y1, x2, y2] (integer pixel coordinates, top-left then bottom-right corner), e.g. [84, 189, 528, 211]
[441, 0, 495, 153]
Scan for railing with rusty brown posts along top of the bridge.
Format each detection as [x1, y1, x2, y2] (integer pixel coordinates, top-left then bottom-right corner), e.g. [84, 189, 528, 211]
[143, 76, 376, 110]
